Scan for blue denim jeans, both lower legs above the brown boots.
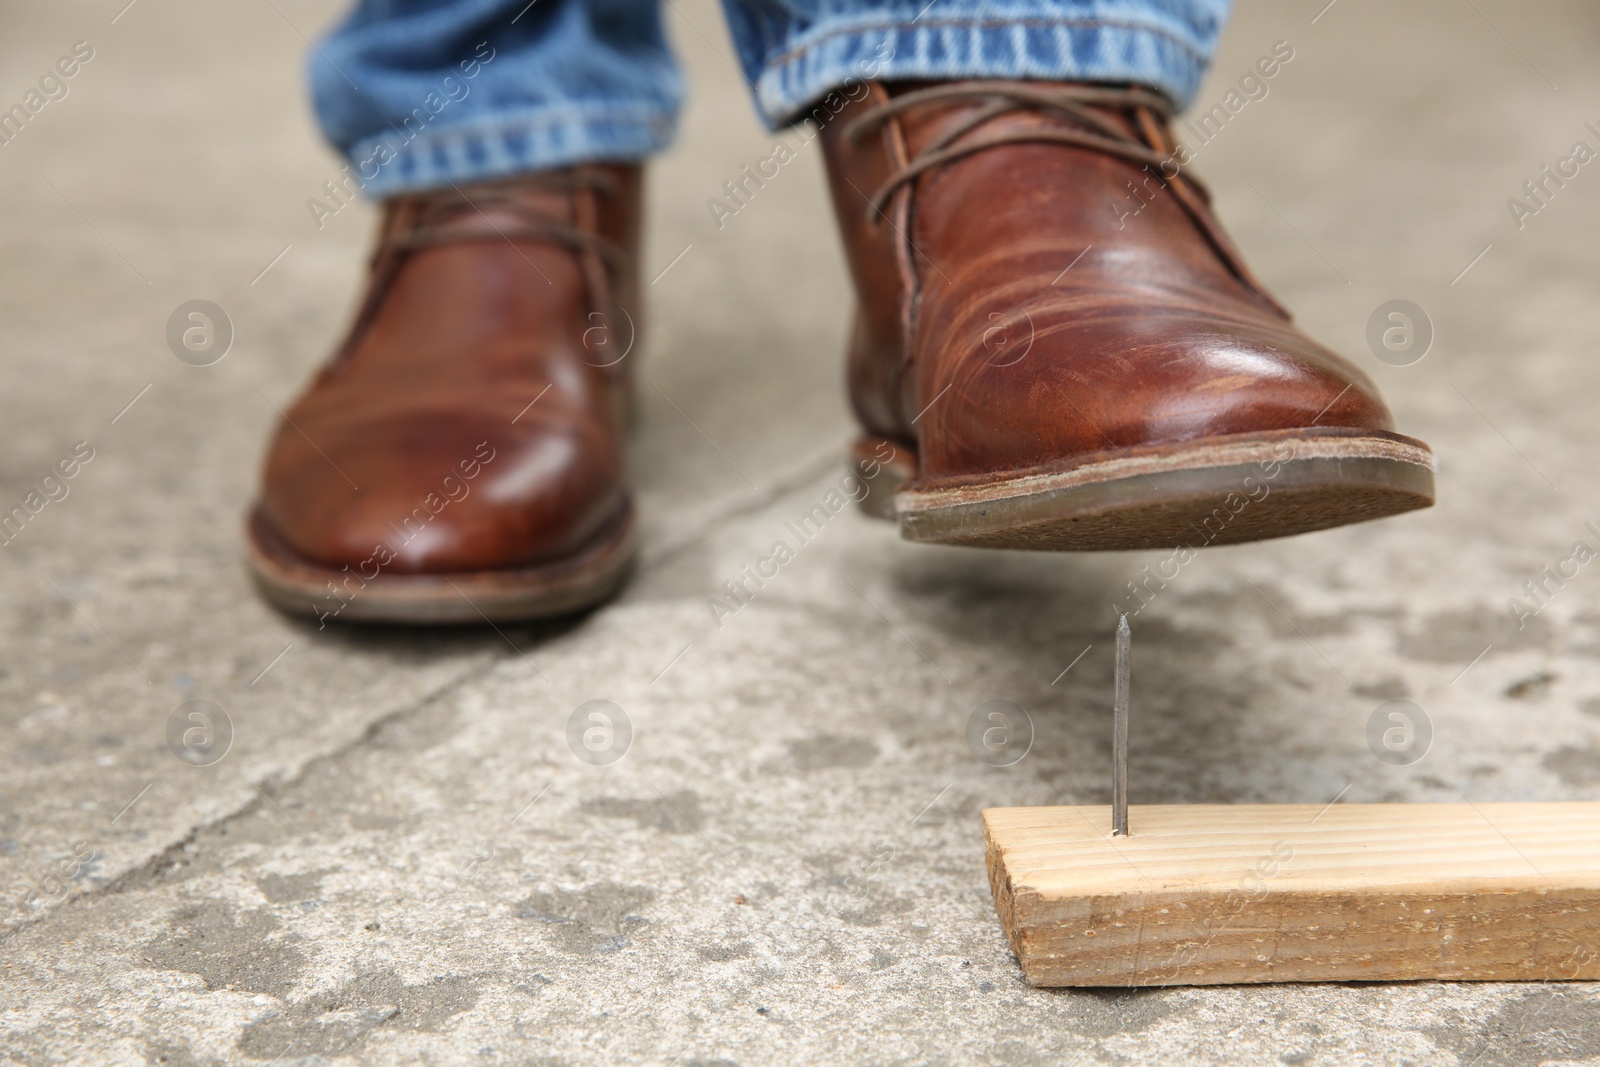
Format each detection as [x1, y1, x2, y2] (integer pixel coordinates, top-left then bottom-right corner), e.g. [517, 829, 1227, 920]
[309, 0, 1230, 197]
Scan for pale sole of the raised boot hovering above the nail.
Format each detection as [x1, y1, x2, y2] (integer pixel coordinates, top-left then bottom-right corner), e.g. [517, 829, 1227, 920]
[854, 429, 1434, 552]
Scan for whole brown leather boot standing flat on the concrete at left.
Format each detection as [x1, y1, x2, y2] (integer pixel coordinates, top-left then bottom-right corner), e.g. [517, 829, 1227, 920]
[248, 166, 640, 622]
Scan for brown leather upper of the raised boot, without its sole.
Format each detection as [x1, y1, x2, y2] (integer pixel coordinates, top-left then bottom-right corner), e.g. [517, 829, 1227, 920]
[822, 83, 1394, 478]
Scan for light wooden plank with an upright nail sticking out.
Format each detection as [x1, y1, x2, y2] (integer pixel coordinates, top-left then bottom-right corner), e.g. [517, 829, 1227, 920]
[984, 803, 1600, 985]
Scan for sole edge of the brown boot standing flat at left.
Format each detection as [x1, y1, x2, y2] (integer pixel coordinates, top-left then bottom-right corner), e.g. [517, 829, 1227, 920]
[245, 504, 635, 625]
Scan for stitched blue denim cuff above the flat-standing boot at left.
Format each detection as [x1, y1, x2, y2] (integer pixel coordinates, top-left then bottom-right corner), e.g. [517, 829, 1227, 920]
[349, 102, 677, 200]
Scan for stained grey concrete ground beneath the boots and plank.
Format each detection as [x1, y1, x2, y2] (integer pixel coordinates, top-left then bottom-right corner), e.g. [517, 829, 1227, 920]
[0, 0, 1600, 1067]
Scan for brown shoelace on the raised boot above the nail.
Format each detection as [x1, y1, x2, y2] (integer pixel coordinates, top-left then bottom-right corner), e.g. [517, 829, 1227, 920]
[843, 82, 1288, 318]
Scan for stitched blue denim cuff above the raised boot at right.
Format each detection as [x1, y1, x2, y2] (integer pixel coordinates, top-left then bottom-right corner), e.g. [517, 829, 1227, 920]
[755, 15, 1214, 130]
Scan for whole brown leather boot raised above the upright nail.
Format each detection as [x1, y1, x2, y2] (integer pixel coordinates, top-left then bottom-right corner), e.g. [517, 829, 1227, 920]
[822, 82, 1434, 549]
